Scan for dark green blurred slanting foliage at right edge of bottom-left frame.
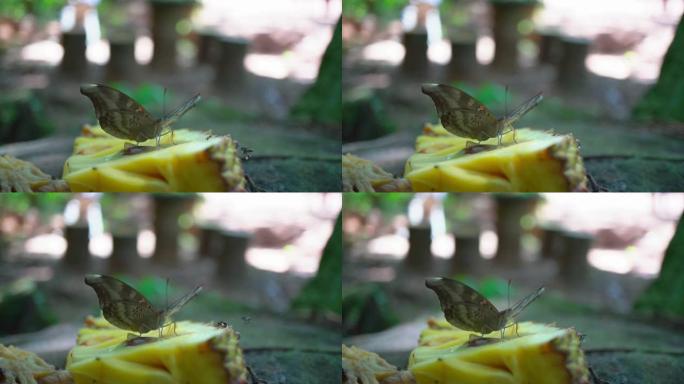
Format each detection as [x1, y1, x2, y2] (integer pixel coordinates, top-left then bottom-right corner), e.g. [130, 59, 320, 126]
[291, 213, 342, 315]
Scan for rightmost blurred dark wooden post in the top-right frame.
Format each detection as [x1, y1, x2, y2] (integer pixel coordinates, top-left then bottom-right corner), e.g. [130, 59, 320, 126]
[556, 37, 591, 91]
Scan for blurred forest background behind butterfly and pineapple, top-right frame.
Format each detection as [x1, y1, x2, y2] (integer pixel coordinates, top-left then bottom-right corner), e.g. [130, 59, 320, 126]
[343, 0, 684, 192]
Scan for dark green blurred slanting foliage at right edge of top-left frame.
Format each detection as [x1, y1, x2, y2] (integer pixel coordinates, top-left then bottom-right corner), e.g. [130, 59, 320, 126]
[290, 19, 342, 133]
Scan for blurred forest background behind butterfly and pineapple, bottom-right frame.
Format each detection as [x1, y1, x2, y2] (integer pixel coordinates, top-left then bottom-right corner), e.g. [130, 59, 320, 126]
[342, 193, 684, 383]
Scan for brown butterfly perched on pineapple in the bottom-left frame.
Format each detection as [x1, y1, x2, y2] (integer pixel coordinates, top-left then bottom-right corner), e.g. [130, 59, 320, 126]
[85, 275, 202, 335]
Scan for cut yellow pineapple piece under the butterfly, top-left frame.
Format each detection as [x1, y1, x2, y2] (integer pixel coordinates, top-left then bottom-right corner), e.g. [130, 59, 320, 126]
[63, 126, 245, 192]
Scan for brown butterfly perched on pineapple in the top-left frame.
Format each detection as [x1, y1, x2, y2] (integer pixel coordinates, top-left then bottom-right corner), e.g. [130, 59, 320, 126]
[81, 84, 201, 146]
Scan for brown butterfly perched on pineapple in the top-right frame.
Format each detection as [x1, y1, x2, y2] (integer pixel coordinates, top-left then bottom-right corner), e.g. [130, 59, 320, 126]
[421, 84, 543, 144]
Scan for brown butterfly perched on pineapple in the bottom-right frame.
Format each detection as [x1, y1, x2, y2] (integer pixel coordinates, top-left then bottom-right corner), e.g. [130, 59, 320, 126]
[425, 277, 544, 335]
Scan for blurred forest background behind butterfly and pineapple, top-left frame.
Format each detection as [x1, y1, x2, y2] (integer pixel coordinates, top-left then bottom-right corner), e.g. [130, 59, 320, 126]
[0, 0, 342, 191]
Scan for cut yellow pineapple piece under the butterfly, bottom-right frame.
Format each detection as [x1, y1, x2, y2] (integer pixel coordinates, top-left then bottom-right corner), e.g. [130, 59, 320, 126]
[409, 320, 589, 384]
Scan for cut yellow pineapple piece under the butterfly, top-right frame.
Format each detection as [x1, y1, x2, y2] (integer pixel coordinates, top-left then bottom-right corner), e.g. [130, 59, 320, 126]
[404, 125, 587, 192]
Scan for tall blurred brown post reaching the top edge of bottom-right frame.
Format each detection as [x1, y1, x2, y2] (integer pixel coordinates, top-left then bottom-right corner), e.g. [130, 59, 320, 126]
[494, 195, 537, 267]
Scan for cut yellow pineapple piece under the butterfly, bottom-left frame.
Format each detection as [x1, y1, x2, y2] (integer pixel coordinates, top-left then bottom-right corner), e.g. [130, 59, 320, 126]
[66, 317, 247, 384]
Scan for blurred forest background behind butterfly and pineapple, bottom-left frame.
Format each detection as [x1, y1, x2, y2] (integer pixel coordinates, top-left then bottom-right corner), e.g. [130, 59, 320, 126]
[0, 193, 342, 382]
